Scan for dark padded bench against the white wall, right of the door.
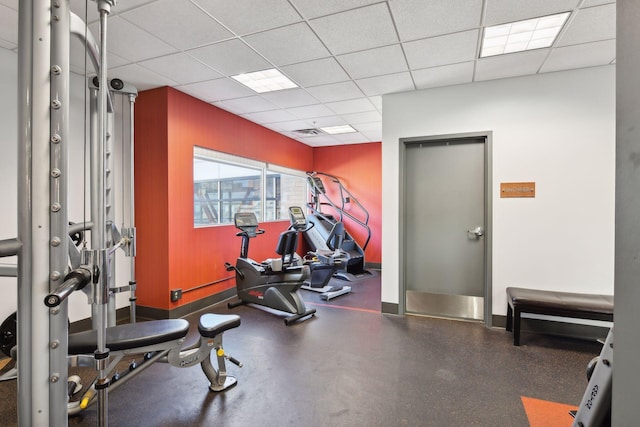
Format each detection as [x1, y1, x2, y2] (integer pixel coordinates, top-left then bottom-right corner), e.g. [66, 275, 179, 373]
[506, 287, 613, 345]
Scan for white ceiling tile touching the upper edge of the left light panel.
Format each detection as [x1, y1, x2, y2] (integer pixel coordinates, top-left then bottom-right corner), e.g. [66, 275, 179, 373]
[188, 39, 272, 76]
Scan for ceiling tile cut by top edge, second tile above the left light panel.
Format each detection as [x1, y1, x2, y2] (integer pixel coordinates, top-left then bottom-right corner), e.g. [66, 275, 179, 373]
[193, 0, 301, 35]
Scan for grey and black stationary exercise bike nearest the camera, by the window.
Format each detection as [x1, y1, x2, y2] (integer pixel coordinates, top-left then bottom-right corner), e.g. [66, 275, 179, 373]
[225, 212, 316, 326]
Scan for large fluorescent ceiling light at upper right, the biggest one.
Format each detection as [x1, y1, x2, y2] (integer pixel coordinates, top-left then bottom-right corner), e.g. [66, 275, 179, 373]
[480, 12, 570, 58]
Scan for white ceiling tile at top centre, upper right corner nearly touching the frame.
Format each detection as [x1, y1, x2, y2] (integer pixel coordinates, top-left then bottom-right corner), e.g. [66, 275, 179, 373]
[310, 3, 398, 55]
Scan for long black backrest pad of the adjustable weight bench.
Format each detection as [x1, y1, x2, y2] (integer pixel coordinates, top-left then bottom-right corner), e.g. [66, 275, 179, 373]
[69, 319, 189, 354]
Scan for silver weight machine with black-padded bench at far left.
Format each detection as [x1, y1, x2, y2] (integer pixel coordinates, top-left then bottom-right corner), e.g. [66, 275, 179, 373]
[11, 0, 240, 427]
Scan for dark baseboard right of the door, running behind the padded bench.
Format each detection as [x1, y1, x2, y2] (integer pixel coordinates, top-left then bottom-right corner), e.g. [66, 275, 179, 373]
[493, 314, 609, 341]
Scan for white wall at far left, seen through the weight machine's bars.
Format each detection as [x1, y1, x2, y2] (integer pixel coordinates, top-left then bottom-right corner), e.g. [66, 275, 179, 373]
[0, 48, 130, 323]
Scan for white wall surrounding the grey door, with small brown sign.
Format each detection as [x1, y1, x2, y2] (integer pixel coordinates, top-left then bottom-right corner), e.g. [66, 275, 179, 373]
[382, 66, 615, 315]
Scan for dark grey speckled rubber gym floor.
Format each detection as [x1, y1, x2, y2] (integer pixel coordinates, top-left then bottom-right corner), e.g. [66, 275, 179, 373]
[0, 277, 600, 427]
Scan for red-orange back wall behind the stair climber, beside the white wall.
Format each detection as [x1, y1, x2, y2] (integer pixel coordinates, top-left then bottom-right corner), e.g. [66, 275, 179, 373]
[313, 142, 382, 263]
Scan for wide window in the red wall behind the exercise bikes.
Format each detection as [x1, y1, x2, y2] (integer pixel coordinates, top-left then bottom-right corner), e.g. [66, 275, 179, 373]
[193, 147, 307, 227]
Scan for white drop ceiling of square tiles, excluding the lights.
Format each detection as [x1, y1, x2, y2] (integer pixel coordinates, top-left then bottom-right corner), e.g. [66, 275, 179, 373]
[0, 0, 616, 147]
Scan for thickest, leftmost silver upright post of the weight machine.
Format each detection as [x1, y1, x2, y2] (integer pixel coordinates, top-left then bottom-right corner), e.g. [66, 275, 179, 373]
[17, 0, 51, 426]
